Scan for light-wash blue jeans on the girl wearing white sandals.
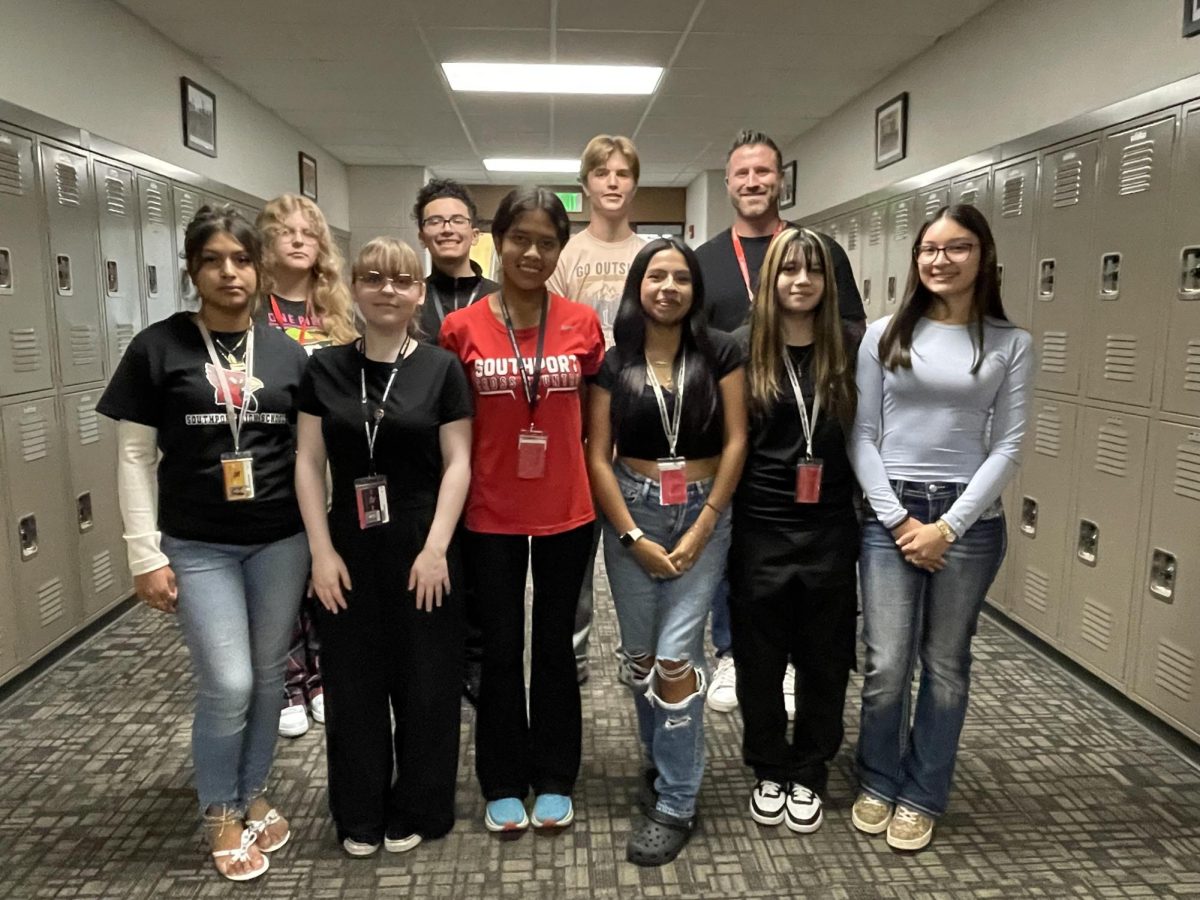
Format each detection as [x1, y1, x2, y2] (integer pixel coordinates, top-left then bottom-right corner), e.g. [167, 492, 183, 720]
[162, 532, 310, 812]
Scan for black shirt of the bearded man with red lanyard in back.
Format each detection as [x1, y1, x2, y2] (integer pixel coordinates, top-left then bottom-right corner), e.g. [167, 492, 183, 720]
[696, 228, 866, 332]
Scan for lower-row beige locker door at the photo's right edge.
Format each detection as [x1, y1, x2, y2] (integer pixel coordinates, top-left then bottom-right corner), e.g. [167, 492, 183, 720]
[1133, 422, 1200, 740]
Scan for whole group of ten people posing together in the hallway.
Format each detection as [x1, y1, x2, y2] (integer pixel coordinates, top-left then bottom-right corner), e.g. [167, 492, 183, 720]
[100, 134, 1031, 881]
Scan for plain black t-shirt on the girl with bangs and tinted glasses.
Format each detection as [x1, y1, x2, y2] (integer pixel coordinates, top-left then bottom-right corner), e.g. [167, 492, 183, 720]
[298, 342, 473, 532]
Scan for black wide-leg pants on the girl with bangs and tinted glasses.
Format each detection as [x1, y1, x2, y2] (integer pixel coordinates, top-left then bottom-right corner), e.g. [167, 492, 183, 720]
[317, 509, 463, 842]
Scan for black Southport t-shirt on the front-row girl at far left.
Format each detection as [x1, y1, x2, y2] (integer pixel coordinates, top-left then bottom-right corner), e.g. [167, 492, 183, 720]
[96, 312, 307, 545]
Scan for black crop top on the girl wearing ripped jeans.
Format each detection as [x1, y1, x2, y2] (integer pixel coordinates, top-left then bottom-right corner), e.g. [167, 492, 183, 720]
[595, 331, 745, 460]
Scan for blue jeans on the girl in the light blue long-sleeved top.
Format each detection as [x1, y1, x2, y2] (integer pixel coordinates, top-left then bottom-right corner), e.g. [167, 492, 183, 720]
[857, 481, 1007, 817]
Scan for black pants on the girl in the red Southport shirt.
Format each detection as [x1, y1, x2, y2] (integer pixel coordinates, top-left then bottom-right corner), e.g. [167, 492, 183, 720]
[464, 522, 593, 800]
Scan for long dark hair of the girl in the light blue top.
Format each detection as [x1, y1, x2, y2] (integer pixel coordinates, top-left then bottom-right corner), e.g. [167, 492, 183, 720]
[880, 203, 1008, 374]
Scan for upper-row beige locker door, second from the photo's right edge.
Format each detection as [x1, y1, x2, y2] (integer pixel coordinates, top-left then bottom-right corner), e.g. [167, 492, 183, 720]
[1085, 115, 1176, 406]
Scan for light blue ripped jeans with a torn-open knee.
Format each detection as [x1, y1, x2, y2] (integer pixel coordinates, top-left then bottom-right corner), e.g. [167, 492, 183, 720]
[604, 462, 730, 818]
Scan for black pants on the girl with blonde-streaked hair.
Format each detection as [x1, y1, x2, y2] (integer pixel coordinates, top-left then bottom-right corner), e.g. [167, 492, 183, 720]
[730, 518, 859, 793]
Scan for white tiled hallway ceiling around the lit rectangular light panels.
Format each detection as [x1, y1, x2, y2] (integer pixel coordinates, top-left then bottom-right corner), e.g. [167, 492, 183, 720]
[118, 0, 994, 186]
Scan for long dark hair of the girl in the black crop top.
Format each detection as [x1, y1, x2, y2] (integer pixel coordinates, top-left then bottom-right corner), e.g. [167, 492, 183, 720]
[612, 238, 721, 433]
